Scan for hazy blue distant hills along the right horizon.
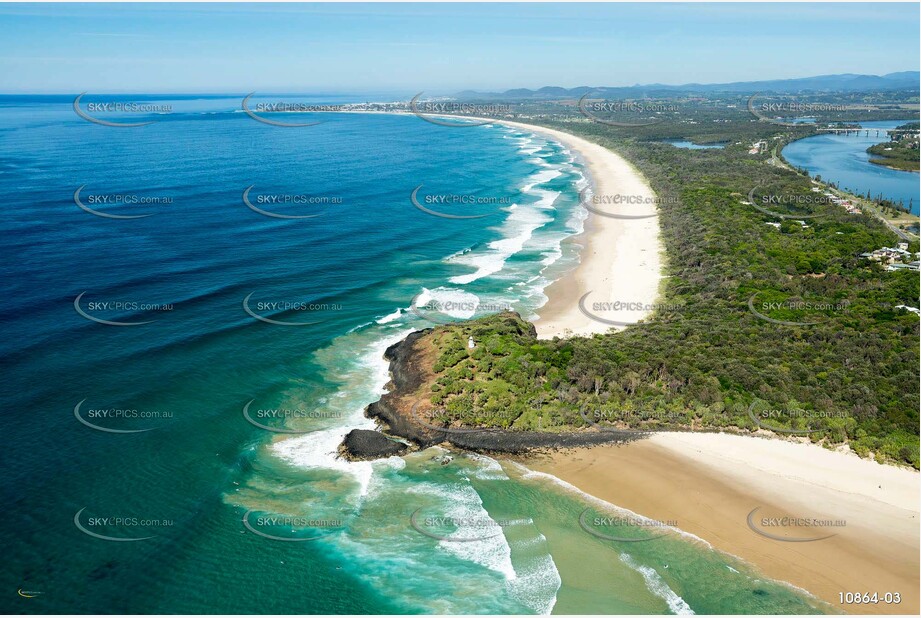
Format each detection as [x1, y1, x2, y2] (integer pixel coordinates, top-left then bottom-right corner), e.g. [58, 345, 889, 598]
[455, 71, 921, 99]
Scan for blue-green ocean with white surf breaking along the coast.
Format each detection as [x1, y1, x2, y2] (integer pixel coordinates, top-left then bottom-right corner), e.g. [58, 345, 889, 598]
[0, 97, 822, 613]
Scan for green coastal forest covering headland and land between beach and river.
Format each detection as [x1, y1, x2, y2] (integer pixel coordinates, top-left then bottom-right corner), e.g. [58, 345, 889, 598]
[416, 104, 921, 468]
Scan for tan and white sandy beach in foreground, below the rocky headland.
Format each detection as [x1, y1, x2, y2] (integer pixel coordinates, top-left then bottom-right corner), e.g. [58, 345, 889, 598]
[525, 433, 921, 614]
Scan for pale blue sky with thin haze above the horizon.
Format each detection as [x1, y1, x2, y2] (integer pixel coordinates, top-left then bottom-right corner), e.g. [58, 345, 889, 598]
[0, 2, 921, 94]
